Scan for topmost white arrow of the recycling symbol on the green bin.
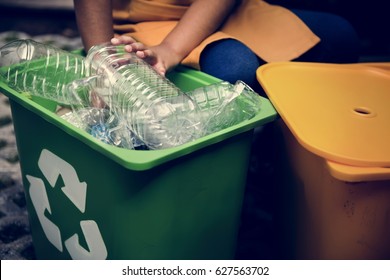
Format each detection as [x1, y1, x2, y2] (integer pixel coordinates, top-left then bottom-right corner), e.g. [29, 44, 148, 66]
[38, 149, 87, 213]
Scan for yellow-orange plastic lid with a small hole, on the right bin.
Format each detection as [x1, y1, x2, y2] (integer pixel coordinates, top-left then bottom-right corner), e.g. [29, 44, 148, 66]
[257, 62, 390, 181]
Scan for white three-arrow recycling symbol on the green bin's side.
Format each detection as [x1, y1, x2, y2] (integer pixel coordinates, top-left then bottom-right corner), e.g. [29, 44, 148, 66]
[26, 149, 107, 260]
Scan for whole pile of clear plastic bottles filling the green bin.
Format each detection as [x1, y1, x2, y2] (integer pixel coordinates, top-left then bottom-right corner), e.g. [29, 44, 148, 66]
[0, 40, 261, 150]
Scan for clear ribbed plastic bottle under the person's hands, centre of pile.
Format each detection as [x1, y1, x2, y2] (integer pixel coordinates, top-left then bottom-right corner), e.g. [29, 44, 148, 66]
[86, 44, 203, 149]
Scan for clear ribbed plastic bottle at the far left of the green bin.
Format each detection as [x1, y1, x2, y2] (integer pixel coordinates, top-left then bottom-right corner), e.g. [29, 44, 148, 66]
[0, 39, 85, 104]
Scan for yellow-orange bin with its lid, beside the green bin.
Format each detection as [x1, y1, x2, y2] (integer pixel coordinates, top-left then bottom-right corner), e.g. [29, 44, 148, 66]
[257, 62, 390, 259]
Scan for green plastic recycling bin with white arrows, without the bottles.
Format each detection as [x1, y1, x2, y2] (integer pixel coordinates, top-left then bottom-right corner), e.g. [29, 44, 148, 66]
[0, 64, 276, 259]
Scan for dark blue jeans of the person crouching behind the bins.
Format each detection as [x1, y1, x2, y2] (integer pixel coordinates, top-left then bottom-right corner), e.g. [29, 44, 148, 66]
[200, 10, 360, 93]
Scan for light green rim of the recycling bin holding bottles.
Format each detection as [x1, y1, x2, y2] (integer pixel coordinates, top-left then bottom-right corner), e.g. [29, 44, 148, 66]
[0, 66, 277, 171]
